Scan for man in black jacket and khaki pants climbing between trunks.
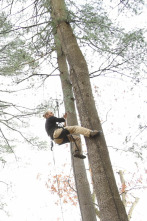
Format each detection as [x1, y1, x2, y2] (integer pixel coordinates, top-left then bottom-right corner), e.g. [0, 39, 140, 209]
[43, 111, 101, 159]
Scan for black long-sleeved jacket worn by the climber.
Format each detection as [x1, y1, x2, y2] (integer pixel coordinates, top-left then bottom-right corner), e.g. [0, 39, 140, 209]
[45, 116, 65, 139]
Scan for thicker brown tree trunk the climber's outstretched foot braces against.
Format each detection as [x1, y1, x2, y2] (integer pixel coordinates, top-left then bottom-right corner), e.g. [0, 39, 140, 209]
[50, 0, 128, 221]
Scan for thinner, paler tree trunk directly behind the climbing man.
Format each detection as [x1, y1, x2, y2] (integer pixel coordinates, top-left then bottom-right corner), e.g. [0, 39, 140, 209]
[55, 30, 96, 221]
